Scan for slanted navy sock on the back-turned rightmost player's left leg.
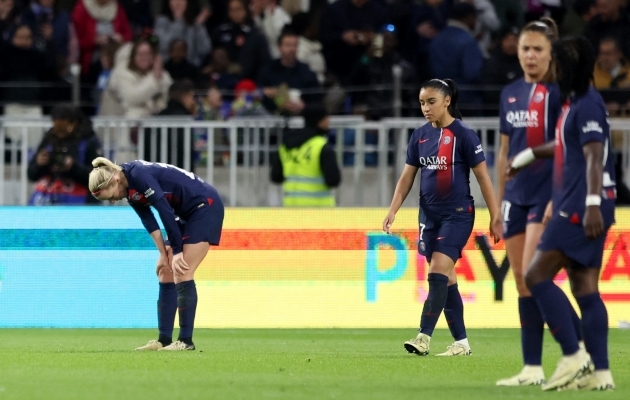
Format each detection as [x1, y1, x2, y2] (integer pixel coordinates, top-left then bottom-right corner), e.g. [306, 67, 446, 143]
[530, 280, 579, 356]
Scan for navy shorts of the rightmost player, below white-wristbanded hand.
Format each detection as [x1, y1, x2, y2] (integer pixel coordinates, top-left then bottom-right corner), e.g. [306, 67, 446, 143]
[538, 214, 610, 268]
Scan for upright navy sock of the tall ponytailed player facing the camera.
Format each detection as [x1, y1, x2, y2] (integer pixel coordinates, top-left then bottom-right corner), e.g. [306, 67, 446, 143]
[518, 297, 545, 365]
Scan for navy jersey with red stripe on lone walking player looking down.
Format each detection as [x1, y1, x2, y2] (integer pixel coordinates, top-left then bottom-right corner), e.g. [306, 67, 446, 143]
[407, 119, 486, 209]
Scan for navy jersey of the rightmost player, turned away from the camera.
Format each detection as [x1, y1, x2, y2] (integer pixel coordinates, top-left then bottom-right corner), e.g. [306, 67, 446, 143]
[553, 87, 616, 226]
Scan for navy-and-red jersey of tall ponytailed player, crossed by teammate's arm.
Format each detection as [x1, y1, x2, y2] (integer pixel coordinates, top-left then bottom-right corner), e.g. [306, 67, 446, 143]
[499, 79, 561, 206]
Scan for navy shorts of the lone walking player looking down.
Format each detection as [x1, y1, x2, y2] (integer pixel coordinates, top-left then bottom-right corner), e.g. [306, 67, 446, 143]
[418, 207, 475, 262]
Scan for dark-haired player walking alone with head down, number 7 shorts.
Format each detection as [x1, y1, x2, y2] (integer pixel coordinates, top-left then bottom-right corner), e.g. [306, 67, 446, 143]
[383, 79, 502, 356]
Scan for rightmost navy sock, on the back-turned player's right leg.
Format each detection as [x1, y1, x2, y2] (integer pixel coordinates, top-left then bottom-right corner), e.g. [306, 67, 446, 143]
[576, 292, 608, 369]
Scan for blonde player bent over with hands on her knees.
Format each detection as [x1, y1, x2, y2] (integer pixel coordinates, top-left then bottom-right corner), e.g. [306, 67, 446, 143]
[89, 157, 224, 351]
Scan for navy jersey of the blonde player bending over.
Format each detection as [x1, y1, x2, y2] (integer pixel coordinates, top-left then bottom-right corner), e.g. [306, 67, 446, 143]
[121, 160, 219, 254]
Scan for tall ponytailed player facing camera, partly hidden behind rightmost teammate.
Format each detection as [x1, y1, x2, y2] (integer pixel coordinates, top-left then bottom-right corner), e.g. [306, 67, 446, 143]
[497, 18, 581, 386]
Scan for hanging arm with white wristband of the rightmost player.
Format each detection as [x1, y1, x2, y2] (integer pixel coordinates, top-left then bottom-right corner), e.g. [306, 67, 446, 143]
[582, 142, 604, 239]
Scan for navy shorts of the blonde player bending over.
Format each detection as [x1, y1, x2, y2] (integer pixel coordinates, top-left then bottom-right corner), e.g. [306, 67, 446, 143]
[172, 196, 224, 246]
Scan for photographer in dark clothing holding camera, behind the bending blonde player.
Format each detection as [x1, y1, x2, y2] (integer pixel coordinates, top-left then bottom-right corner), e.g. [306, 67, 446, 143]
[28, 105, 103, 206]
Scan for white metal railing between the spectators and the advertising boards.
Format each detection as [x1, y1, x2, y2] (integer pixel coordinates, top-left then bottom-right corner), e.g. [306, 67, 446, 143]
[0, 116, 630, 206]
